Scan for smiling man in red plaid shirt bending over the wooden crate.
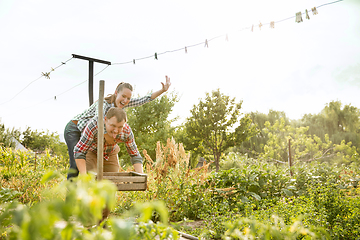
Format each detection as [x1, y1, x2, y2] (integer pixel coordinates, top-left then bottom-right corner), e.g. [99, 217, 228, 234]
[74, 107, 143, 174]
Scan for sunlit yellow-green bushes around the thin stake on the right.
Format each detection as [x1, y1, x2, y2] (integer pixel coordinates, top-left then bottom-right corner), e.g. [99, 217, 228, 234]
[259, 119, 358, 164]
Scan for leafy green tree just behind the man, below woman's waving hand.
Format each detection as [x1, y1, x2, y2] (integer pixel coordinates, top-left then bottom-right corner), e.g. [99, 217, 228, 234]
[119, 92, 178, 166]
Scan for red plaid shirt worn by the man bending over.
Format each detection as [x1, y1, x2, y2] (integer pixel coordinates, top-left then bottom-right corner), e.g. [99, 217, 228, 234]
[74, 117, 142, 164]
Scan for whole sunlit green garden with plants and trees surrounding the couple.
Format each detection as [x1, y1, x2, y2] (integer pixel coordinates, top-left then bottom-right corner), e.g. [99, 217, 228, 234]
[0, 92, 360, 239]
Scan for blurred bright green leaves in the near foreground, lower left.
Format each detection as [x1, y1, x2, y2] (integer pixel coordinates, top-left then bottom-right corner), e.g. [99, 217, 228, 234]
[0, 173, 179, 240]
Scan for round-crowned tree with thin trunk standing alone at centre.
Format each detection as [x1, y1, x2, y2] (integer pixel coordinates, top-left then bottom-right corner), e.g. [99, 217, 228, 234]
[185, 89, 255, 171]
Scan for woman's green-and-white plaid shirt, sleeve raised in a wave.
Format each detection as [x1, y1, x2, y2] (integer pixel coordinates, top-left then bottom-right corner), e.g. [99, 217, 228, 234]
[71, 93, 153, 132]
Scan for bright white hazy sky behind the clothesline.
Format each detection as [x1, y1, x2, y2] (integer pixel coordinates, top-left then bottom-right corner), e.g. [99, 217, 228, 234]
[0, 0, 360, 140]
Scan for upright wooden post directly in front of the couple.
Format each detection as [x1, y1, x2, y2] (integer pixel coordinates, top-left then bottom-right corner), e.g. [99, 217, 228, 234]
[97, 80, 105, 181]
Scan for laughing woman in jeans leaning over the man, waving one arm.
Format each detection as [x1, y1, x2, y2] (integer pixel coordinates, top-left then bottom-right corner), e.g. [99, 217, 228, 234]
[64, 76, 171, 179]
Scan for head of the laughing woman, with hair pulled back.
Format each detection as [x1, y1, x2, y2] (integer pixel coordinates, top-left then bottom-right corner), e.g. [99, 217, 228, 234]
[105, 82, 133, 108]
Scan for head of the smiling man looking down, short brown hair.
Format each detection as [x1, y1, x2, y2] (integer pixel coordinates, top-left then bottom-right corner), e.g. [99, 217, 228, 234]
[104, 107, 126, 138]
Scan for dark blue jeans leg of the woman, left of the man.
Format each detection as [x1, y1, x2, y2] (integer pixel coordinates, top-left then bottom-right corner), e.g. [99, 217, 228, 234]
[64, 121, 81, 180]
